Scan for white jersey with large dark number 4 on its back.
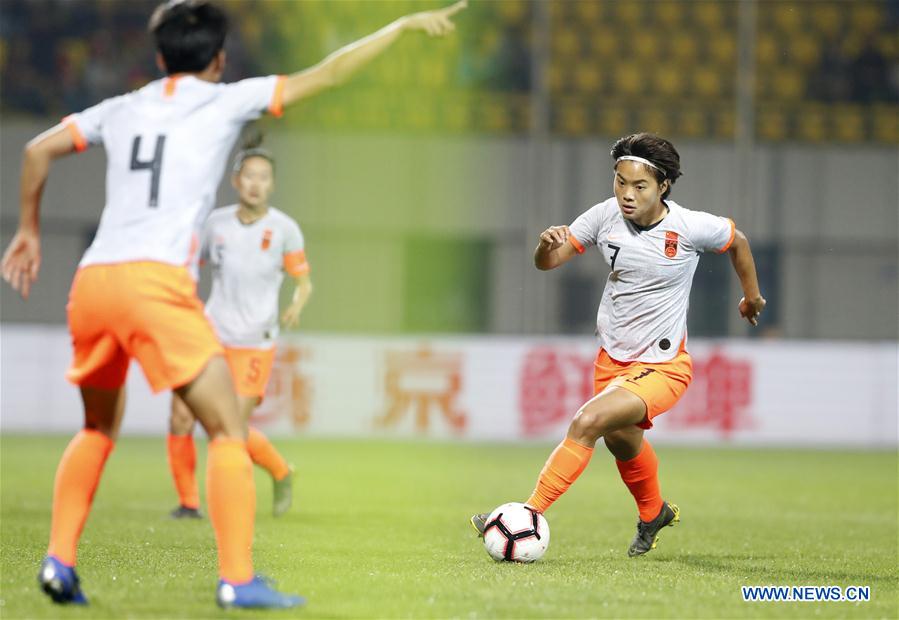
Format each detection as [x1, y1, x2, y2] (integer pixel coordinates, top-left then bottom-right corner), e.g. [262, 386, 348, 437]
[64, 75, 283, 266]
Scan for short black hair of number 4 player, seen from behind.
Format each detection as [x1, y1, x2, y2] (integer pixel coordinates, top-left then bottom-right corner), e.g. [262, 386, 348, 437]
[148, 0, 228, 75]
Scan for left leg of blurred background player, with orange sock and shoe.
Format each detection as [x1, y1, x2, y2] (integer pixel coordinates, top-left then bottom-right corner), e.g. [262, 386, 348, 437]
[166, 393, 203, 519]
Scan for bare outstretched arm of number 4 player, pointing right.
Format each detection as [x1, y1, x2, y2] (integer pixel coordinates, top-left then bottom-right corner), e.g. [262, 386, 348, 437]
[284, 0, 468, 106]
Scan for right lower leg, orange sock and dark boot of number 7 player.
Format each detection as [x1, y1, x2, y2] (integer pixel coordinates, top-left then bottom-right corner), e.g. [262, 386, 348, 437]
[603, 426, 680, 557]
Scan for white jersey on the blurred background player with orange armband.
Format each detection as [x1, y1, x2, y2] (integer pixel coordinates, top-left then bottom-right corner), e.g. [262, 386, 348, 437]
[203, 205, 309, 349]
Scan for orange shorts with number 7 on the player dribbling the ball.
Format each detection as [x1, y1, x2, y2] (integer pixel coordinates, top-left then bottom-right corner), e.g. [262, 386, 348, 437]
[593, 349, 693, 429]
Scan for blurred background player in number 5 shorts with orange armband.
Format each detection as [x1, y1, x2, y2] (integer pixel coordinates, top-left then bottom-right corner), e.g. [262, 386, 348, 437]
[168, 136, 312, 518]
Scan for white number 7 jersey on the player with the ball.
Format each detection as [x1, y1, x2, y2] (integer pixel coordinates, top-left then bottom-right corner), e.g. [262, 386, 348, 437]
[570, 197, 735, 362]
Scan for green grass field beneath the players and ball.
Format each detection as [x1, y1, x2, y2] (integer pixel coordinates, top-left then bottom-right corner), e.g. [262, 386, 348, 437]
[0, 435, 899, 618]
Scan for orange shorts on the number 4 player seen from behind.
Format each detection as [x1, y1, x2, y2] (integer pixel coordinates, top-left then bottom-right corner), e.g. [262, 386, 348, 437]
[66, 261, 222, 392]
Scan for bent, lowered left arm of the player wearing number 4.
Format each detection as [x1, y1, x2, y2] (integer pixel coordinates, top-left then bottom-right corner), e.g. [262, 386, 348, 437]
[2, 123, 75, 299]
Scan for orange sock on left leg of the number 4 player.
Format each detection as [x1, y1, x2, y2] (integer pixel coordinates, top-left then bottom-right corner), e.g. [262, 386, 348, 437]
[47, 429, 114, 566]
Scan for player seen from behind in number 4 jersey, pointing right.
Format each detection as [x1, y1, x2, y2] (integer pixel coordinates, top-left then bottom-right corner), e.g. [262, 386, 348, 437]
[2, 0, 472, 607]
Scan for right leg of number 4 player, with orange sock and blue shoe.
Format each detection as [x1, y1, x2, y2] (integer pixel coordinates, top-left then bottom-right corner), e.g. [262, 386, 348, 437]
[177, 356, 305, 607]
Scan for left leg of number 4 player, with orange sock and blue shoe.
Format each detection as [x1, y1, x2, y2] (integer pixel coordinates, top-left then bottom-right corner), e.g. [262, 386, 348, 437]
[38, 387, 125, 605]
